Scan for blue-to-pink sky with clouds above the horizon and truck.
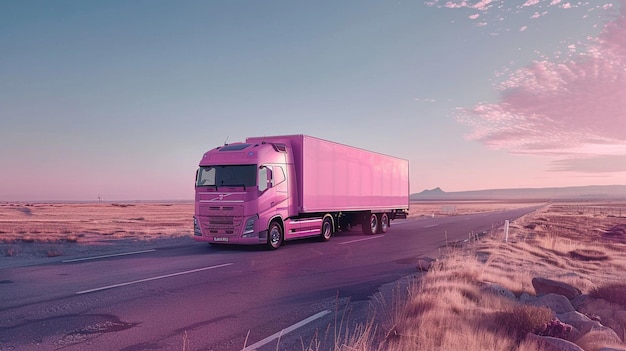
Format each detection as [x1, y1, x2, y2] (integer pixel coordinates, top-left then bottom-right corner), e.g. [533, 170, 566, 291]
[0, 0, 626, 201]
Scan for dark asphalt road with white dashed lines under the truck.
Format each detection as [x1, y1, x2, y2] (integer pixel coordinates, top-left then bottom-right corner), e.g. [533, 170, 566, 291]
[0, 207, 536, 351]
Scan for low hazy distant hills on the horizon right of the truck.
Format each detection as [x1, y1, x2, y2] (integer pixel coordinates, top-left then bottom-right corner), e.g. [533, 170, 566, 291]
[411, 185, 626, 201]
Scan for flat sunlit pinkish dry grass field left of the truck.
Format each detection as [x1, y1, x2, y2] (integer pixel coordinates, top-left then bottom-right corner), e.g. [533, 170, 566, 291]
[0, 203, 193, 244]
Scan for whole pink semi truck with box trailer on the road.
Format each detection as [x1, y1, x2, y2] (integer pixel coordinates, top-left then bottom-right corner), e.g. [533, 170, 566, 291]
[194, 135, 409, 249]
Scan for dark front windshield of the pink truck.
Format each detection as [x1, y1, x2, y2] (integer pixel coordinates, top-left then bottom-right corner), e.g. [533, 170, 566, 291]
[196, 165, 257, 188]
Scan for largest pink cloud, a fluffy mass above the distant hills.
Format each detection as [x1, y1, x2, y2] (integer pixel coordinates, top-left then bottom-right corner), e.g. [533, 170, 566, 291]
[459, 1, 626, 171]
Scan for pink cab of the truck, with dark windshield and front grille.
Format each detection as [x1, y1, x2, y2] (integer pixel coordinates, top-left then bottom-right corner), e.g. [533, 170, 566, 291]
[194, 143, 297, 248]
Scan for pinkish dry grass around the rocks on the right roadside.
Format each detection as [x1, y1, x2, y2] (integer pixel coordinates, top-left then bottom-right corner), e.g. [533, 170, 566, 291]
[342, 204, 626, 351]
